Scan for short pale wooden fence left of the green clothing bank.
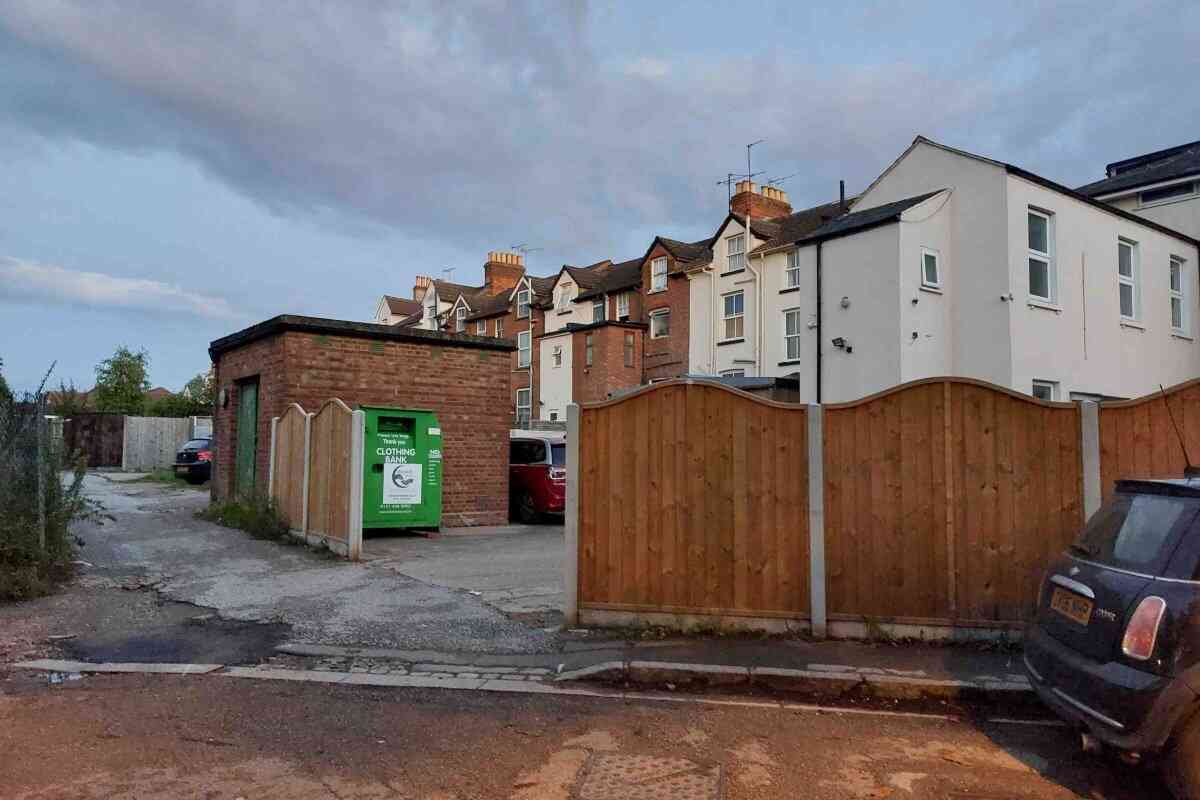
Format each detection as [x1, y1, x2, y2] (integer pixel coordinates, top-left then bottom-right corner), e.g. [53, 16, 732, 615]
[270, 398, 364, 560]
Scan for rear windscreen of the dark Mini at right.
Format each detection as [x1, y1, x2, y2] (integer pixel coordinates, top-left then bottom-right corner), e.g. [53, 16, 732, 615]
[1070, 494, 1200, 575]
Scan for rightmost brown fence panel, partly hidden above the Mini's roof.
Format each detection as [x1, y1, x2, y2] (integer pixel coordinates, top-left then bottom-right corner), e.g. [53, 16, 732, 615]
[1099, 379, 1200, 500]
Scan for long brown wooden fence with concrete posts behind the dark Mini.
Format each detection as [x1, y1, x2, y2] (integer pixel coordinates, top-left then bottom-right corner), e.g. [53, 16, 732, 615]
[565, 378, 1200, 636]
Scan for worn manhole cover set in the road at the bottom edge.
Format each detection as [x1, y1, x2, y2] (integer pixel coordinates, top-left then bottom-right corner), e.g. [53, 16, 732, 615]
[580, 754, 721, 800]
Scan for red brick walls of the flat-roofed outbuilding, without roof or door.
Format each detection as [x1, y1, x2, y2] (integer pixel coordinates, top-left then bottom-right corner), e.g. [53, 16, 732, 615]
[212, 331, 511, 527]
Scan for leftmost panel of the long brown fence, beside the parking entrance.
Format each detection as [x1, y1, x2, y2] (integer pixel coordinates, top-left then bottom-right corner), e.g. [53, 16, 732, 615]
[578, 381, 809, 618]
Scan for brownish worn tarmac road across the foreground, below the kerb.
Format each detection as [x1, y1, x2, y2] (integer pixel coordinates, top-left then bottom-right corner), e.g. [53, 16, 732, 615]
[0, 672, 1165, 800]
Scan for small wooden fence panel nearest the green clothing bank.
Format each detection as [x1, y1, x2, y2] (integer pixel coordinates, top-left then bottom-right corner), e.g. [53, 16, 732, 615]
[308, 398, 354, 546]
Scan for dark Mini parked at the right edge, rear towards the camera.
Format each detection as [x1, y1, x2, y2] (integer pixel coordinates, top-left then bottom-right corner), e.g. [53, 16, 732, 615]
[1025, 477, 1200, 798]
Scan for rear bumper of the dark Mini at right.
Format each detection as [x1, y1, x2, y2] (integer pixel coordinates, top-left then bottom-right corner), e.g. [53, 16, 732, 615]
[1025, 625, 1196, 752]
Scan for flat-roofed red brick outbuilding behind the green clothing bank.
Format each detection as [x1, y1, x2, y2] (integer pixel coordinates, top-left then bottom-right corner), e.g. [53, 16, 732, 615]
[209, 315, 514, 525]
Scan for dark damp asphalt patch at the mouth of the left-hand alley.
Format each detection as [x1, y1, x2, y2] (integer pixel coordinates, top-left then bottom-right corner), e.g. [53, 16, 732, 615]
[58, 602, 292, 664]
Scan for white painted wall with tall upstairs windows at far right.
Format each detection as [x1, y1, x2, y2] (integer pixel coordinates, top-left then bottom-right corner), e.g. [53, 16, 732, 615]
[1008, 175, 1200, 399]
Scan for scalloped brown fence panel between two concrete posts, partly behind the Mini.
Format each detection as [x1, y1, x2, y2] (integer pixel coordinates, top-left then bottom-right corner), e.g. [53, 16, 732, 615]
[824, 379, 1082, 625]
